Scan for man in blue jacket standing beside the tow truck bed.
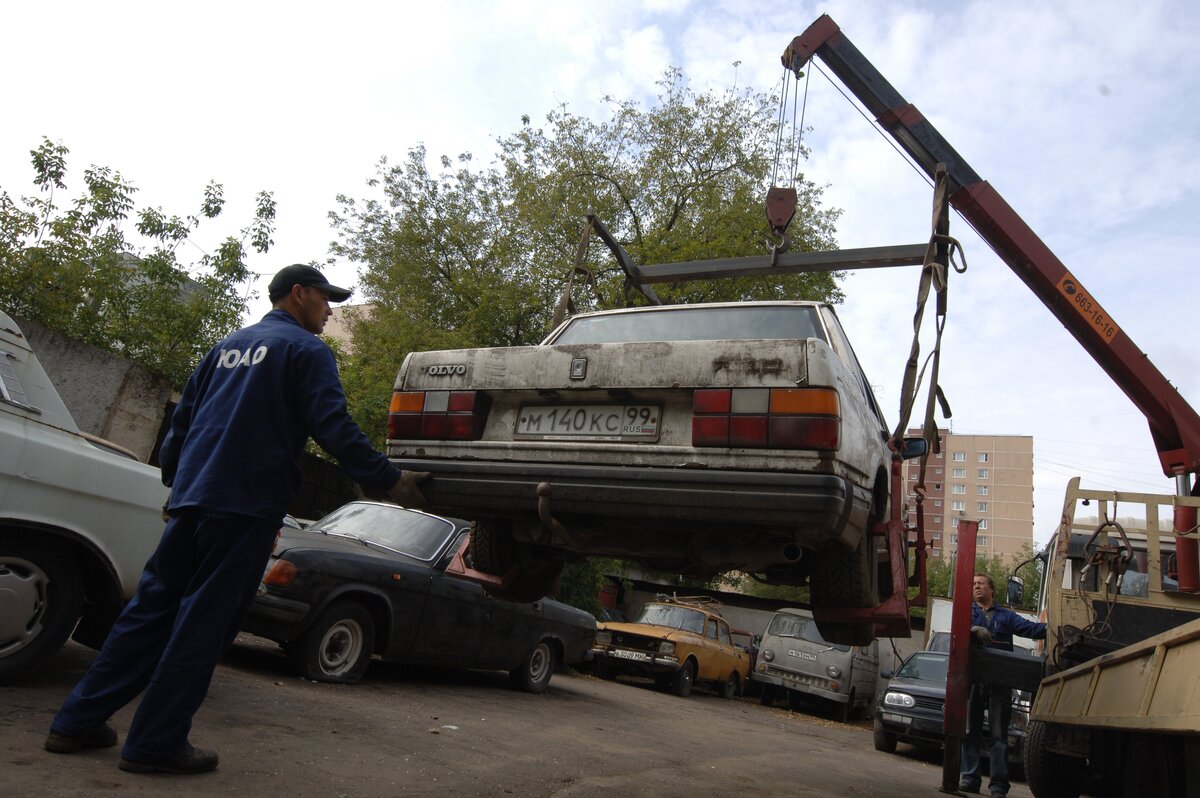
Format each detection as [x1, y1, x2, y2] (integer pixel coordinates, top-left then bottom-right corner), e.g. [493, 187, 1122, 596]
[959, 574, 1046, 798]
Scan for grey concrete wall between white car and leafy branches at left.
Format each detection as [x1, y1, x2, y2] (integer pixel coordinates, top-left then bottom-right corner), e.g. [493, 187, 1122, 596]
[17, 319, 174, 462]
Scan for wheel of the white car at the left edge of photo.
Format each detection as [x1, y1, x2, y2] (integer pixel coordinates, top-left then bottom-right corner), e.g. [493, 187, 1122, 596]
[0, 538, 83, 684]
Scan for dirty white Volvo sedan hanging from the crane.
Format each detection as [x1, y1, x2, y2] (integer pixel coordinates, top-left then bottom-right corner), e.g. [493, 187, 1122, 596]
[388, 301, 920, 643]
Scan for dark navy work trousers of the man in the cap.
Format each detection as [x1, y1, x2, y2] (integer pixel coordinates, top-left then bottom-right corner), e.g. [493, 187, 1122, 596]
[50, 509, 280, 762]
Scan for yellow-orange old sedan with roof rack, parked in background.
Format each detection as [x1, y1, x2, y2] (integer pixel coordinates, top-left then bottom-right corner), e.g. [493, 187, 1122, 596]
[593, 596, 750, 698]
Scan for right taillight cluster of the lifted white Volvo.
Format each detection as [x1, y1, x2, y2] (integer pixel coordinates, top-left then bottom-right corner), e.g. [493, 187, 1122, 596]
[691, 388, 841, 451]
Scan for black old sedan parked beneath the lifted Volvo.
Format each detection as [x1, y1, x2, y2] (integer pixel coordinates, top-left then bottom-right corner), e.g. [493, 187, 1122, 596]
[244, 502, 596, 692]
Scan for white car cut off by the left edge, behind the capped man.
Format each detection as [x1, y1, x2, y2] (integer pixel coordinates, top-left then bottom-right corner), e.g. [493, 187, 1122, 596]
[0, 311, 168, 684]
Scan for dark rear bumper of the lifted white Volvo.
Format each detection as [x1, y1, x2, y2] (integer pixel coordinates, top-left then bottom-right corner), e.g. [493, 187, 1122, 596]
[391, 457, 871, 547]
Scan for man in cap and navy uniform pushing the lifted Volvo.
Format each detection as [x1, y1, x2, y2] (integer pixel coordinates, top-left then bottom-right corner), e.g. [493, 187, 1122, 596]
[46, 264, 428, 774]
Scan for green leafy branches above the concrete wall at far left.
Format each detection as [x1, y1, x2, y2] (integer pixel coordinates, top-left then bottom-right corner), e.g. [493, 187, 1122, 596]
[0, 139, 275, 385]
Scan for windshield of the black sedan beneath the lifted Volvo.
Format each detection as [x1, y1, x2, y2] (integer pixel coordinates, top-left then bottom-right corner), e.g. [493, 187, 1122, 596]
[308, 502, 454, 562]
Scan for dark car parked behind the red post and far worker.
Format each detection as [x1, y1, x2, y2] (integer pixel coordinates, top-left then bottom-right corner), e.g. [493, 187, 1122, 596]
[875, 652, 1030, 778]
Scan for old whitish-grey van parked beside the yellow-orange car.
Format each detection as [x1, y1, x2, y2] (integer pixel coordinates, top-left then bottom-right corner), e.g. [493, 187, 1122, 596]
[750, 608, 880, 721]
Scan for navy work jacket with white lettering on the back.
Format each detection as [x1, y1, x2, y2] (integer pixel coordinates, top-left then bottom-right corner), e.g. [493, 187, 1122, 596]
[160, 308, 400, 521]
